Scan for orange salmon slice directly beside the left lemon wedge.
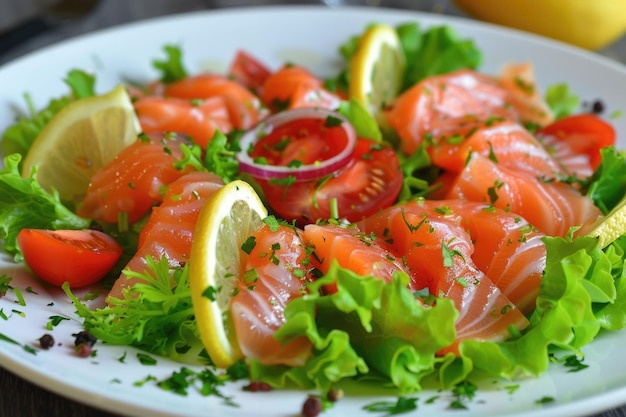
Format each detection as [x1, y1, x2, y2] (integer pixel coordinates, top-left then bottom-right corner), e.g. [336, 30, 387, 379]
[77, 133, 192, 224]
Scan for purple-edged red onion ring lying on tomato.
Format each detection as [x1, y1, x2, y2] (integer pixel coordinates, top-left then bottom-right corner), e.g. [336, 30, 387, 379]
[237, 108, 357, 181]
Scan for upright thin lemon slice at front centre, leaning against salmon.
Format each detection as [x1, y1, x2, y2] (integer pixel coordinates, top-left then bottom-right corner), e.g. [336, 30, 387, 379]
[189, 180, 267, 368]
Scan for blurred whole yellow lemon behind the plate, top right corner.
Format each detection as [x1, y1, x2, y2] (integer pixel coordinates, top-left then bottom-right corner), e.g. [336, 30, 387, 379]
[454, 0, 626, 50]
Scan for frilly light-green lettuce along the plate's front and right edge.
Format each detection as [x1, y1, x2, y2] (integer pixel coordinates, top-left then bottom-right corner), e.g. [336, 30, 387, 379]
[246, 228, 626, 392]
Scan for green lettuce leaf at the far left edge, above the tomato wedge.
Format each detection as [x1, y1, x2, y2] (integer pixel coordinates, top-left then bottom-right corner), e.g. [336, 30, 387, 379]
[0, 154, 91, 262]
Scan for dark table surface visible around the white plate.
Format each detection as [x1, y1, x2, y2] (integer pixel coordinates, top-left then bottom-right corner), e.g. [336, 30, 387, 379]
[0, 0, 626, 417]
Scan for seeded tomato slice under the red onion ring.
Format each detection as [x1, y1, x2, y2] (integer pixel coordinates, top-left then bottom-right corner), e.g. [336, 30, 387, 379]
[258, 138, 403, 225]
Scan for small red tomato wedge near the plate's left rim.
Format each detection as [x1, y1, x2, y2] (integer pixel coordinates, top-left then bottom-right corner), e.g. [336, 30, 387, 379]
[17, 229, 122, 288]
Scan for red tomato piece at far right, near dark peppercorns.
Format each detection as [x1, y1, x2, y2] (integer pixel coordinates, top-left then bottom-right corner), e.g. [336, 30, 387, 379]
[538, 113, 616, 169]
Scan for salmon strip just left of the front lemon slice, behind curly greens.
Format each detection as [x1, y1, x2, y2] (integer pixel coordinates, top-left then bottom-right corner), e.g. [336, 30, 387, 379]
[109, 171, 224, 299]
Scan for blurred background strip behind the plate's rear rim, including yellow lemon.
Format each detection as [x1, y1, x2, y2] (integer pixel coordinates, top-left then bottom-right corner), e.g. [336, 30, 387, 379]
[0, 0, 626, 64]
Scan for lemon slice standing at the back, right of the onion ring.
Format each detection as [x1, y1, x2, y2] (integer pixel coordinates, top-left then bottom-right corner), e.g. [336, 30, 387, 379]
[348, 23, 406, 122]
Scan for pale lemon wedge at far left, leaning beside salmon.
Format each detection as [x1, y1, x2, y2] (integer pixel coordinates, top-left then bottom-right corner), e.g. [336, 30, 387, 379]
[22, 85, 141, 201]
